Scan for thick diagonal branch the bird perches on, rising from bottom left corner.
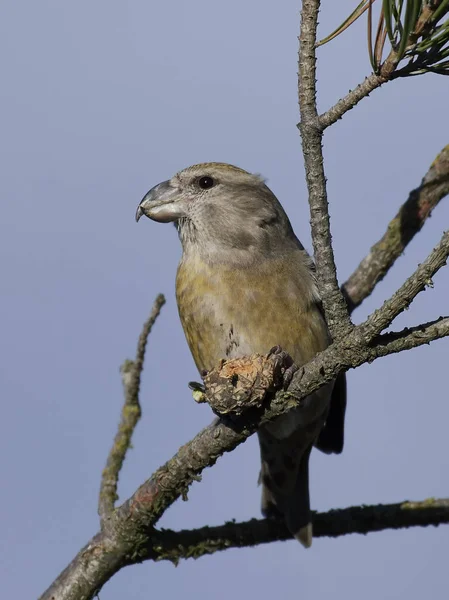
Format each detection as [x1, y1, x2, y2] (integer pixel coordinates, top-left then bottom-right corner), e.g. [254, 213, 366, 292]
[41, 304, 449, 600]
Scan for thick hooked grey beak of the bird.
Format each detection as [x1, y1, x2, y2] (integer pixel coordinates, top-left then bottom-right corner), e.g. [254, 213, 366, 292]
[136, 181, 186, 223]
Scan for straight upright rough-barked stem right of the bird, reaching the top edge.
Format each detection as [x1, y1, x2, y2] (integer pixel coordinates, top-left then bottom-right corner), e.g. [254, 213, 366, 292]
[298, 0, 352, 340]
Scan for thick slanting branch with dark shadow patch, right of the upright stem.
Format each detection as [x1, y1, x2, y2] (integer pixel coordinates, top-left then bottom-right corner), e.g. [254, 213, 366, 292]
[343, 145, 449, 312]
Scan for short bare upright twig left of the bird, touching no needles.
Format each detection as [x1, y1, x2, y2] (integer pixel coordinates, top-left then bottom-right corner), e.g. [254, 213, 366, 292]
[98, 294, 165, 524]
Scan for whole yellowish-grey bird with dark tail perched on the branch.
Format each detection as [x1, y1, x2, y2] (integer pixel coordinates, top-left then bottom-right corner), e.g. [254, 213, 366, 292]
[136, 162, 346, 547]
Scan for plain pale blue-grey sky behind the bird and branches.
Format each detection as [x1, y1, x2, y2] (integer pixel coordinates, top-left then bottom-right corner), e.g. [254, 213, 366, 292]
[0, 0, 449, 600]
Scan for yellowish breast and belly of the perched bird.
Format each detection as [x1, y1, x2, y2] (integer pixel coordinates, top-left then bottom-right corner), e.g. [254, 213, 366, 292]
[176, 251, 329, 371]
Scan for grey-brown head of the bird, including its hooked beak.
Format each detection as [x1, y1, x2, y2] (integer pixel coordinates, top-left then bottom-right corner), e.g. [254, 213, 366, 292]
[136, 163, 299, 263]
